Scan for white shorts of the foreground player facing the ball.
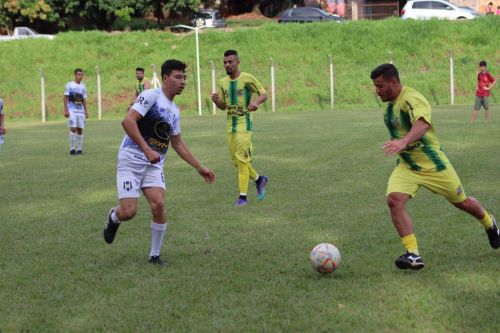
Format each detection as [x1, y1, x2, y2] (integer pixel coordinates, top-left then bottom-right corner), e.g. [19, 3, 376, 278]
[116, 160, 165, 199]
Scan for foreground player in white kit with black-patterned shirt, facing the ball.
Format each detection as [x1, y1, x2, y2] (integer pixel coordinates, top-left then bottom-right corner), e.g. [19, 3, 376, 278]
[103, 59, 215, 265]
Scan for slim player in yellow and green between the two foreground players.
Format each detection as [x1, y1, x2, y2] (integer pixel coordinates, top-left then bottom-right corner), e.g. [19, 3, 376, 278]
[212, 50, 268, 207]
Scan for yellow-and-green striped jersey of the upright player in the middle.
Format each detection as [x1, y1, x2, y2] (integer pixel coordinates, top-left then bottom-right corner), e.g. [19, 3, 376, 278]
[219, 72, 266, 133]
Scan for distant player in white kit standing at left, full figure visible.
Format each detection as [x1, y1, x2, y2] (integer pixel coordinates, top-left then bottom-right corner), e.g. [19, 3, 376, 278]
[64, 68, 89, 155]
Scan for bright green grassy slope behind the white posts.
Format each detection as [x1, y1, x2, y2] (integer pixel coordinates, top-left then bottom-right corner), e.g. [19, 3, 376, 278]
[0, 17, 500, 119]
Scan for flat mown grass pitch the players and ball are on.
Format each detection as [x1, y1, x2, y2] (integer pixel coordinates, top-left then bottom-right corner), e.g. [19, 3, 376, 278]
[0, 107, 500, 333]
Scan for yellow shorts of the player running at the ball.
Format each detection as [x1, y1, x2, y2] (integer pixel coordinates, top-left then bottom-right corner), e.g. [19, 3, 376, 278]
[387, 164, 467, 203]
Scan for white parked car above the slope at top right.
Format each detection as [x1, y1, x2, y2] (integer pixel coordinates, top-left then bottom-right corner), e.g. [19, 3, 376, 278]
[401, 0, 481, 20]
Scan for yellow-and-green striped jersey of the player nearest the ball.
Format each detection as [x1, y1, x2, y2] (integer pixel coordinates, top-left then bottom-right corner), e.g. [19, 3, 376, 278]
[384, 87, 449, 171]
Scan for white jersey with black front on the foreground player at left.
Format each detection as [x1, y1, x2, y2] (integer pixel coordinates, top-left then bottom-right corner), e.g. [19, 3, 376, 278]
[118, 88, 181, 168]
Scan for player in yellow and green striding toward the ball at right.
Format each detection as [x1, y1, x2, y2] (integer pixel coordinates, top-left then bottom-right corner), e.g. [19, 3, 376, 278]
[370, 64, 500, 269]
